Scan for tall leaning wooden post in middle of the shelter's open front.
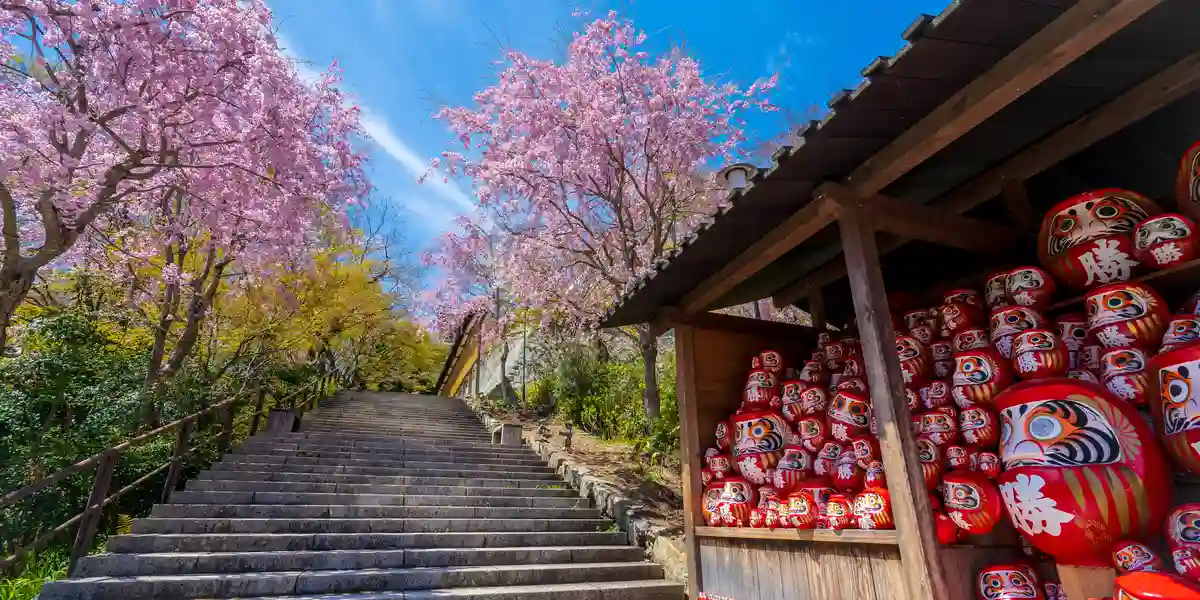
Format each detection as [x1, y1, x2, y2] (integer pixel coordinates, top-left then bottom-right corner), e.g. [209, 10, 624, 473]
[840, 201, 950, 600]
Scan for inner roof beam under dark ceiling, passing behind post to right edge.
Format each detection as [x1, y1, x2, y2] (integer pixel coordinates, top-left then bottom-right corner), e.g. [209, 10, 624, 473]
[774, 47, 1200, 307]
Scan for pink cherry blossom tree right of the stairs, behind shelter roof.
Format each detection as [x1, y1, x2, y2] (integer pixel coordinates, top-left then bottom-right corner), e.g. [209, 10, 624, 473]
[433, 12, 775, 419]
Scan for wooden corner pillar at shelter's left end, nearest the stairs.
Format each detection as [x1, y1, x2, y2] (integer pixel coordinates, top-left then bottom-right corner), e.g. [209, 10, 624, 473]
[674, 323, 704, 599]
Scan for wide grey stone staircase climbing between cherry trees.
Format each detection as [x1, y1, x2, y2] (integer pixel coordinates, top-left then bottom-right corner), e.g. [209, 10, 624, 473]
[40, 392, 683, 600]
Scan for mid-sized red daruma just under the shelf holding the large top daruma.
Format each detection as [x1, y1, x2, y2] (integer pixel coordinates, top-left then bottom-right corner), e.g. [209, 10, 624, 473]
[1084, 282, 1170, 350]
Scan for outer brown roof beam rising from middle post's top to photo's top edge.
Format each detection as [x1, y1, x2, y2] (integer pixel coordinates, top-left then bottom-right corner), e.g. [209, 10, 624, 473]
[846, 0, 1162, 198]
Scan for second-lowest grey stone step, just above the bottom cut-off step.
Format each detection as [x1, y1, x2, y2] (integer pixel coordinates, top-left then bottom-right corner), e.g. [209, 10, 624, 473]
[40, 563, 662, 600]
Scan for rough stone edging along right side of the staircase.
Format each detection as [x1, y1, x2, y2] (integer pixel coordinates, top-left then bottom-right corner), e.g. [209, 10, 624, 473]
[466, 400, 688, 581]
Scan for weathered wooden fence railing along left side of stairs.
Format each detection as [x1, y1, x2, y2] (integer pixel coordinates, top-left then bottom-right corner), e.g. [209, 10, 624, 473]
[0, 379, 330, 576]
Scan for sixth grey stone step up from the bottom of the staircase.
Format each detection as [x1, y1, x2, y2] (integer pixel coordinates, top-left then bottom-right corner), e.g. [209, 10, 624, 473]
[150, 504, 601, 518]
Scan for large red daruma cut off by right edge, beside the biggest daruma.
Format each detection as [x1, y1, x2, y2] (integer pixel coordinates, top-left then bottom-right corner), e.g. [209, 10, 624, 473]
[1147, 344, 1200, 475]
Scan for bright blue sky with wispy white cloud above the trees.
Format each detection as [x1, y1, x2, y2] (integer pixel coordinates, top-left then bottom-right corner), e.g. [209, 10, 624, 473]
[268, 0, 948, 251]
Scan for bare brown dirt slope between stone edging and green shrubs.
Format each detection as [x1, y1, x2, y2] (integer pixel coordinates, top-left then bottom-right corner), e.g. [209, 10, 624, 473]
[477, 403, 683, 535]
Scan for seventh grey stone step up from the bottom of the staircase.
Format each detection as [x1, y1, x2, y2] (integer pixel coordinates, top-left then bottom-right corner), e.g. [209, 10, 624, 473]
[170, 490, 592, 509]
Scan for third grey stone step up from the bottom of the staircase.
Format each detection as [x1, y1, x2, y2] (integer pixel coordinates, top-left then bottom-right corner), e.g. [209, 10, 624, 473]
[76, 546, 644, 577]
